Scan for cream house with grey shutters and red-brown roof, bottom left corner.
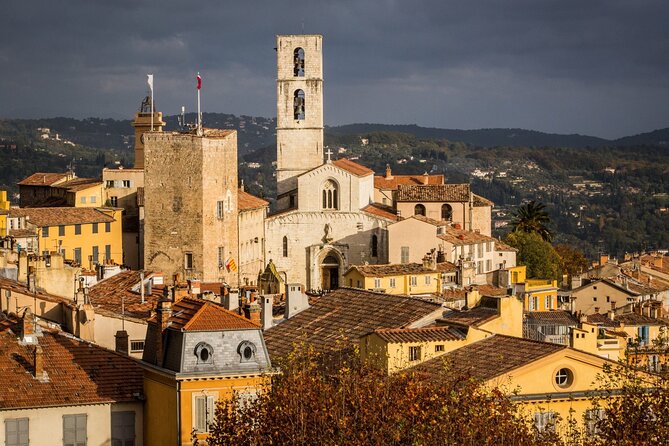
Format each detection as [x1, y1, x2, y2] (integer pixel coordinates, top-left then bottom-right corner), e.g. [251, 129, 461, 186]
[0, 311, 145, 446]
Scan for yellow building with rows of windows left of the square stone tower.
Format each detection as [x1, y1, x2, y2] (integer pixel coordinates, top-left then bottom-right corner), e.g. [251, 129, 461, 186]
[10, 207, 123, 269]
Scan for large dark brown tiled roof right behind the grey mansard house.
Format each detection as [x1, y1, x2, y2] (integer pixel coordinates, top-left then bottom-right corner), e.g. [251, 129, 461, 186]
[264, 287, 441, 358]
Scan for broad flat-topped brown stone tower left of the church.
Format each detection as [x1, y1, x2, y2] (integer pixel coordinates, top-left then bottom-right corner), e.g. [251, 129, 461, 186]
[144, 129, 239, 287]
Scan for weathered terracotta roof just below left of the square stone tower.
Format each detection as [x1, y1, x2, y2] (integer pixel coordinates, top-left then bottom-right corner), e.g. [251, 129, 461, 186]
[88, 270, 163, 321]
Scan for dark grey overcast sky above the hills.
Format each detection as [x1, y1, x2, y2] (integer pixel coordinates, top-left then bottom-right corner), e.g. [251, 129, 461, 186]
[0, 0, 669, 138]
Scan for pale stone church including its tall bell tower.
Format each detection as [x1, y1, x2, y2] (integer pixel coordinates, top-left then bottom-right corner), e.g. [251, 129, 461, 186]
[265, 35, 397, 291]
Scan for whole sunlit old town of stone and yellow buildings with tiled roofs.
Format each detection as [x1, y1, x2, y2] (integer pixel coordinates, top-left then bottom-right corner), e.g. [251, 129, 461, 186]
[0, 35, 669, 445]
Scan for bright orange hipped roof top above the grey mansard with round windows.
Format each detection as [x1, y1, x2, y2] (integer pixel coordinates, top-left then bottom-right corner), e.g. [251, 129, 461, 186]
[151, 297, 260, 331]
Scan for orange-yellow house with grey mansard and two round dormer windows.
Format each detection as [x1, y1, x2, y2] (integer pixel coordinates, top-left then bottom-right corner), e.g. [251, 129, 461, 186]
[142, 297, 272, 446]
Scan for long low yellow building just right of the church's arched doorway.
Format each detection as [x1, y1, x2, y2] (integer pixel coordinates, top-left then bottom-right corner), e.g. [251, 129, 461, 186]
[344, 259, 457, 296]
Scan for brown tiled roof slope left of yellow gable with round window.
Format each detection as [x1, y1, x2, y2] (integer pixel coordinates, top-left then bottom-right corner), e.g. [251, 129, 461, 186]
[412, 334, 567, 381]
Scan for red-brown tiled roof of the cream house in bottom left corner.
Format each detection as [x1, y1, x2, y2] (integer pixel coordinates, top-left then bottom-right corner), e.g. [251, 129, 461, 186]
[0, 319, 143, 410]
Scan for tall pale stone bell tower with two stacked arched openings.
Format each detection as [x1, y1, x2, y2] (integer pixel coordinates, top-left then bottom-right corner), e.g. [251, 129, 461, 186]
[276, 35, 323, 209]
